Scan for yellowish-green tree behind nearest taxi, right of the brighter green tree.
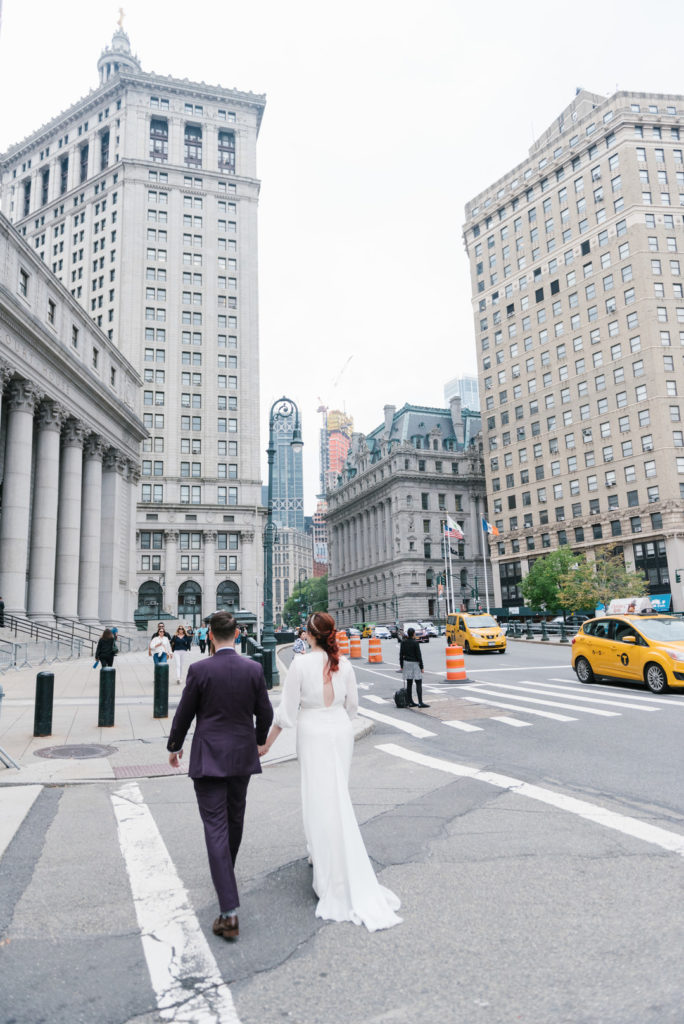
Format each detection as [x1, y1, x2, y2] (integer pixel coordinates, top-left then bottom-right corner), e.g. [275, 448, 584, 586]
[559, 545, 648, 611]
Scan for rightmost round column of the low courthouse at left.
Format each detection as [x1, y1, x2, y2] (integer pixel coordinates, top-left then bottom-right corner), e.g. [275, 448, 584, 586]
[98, 447, 130, 626]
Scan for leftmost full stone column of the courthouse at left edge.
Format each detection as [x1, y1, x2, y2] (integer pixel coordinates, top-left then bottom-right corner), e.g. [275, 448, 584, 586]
[0, 380, 39, 615]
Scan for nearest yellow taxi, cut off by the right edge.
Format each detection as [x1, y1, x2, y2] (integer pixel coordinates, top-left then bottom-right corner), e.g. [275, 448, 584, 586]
[572, 612, 684, 693]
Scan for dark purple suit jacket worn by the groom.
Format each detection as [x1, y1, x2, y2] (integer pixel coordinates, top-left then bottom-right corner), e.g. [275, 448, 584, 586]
[167, 648, 273, 778]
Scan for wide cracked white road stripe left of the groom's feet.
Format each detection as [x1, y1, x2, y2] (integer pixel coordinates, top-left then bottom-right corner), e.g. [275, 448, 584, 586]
[112, 782, 240, 1024]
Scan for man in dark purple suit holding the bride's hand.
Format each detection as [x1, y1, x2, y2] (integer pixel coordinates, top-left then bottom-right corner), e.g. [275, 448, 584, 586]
[167, 611, 273, 939]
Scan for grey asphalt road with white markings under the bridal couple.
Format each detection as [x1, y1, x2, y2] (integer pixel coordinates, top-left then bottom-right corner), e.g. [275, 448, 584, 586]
[0, 640, 684, 1024]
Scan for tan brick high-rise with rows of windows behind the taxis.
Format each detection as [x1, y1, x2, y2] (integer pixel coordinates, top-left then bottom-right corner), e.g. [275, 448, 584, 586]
[464, 91, 684, 611]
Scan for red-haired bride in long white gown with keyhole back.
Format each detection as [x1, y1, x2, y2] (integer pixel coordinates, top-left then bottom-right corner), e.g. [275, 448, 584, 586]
[259, 611, 401, 932]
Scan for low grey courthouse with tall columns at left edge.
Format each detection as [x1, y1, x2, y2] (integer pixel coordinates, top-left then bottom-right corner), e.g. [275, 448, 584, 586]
[0, 214, 146, 626]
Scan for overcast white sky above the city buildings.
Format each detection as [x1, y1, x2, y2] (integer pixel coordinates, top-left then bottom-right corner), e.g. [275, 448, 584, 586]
[0, 0, 684, 513]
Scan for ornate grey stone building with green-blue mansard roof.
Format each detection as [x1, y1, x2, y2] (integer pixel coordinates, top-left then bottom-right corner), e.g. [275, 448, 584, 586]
[327, 396, 485, 626]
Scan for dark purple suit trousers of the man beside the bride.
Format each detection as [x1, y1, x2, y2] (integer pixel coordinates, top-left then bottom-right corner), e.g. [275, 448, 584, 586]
[194, 775, 251, 912]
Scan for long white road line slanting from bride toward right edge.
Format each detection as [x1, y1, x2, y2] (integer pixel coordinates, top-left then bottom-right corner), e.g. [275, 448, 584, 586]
[376, 743, 684, 857]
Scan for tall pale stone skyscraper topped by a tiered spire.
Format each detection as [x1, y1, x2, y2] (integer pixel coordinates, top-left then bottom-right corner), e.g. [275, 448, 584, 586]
[0, 28, 264, 623]
